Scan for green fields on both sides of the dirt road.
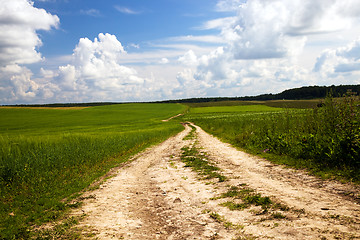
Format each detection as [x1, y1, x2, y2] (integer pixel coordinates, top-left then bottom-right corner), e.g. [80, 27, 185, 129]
[0, 96, 360, 239]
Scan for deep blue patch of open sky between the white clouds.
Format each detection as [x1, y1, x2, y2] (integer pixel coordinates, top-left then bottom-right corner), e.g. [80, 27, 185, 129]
[34, 0, 226, 55]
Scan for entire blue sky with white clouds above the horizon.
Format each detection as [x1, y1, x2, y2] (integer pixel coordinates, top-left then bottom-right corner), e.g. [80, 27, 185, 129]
[0, 0, 360, 105]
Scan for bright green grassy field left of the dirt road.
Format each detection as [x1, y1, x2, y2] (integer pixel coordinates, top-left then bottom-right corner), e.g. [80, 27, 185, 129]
[0, 104, 185, 239]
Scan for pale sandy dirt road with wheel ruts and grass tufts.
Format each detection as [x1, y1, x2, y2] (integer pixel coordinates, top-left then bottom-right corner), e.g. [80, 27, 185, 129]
[73, 125, 360, 239]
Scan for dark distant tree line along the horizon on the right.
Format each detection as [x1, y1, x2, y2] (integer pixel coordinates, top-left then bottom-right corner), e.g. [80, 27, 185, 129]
[162, 84, 360, 103]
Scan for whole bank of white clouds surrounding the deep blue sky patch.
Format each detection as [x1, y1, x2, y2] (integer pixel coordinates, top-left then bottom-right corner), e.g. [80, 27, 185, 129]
[0, 0, 360, 103]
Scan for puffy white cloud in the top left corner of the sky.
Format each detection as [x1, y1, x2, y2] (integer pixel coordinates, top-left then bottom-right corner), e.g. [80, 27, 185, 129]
[0, 0, 59, 66]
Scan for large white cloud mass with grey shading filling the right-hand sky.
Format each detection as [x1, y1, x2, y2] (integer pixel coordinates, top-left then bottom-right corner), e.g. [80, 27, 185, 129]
[177, 0, 360, 96]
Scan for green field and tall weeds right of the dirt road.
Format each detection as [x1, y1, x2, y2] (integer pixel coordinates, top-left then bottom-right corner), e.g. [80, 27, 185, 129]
[184, 93, 360, 183]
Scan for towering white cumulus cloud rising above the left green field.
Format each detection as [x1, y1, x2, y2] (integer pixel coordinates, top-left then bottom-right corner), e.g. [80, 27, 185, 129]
[52, 33, 149, 100]
